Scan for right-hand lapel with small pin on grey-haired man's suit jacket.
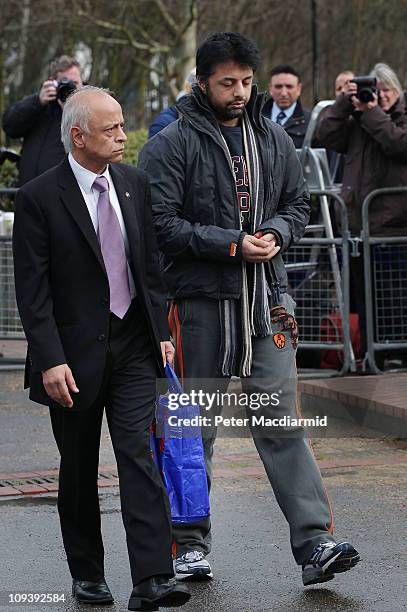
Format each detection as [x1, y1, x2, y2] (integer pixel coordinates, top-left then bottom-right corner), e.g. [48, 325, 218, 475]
[109, 165, 140, 265]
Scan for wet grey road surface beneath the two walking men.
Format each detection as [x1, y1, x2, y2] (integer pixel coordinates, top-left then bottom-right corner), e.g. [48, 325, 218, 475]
[0, 375, 407, 612]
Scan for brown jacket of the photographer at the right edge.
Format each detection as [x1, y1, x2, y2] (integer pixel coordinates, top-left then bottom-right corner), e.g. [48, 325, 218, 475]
[316, 95, 407, 236]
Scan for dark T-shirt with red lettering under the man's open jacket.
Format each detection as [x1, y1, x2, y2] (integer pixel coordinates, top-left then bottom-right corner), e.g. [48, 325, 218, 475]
[219, 125, 250, 233]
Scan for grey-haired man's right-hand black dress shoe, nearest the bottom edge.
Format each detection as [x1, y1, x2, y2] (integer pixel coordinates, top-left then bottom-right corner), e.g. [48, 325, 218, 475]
[129, 576, 191, 610]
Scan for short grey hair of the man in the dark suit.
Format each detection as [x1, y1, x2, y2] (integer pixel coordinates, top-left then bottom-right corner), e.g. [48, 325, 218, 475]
[61, 85, 112, 153]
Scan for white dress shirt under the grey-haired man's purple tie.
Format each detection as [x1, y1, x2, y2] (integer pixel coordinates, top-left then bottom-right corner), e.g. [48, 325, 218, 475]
[68, 153, 136, 299]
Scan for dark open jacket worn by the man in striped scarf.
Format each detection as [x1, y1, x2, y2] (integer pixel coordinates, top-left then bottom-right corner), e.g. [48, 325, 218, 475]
[139, 86, 309, 299]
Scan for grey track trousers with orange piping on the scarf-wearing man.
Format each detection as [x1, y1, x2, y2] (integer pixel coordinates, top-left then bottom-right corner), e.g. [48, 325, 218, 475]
[172, 294, 333, 564]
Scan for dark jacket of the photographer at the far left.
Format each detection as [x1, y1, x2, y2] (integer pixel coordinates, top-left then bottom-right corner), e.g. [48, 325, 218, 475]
[3, 94, 65, 185]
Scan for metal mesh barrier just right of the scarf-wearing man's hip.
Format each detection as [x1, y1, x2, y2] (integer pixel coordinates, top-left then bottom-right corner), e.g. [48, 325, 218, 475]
[284, 189, 355, 376]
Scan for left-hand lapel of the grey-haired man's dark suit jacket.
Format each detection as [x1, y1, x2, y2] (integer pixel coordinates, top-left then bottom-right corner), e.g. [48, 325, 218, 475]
[58, 158, 106, 274]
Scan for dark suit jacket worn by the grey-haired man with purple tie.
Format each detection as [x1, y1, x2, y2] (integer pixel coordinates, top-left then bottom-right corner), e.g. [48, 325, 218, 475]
[13, 158, 169, 409]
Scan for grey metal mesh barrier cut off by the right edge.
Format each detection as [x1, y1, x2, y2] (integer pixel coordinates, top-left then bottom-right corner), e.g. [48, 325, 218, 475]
[361, 187, 407, 374]
